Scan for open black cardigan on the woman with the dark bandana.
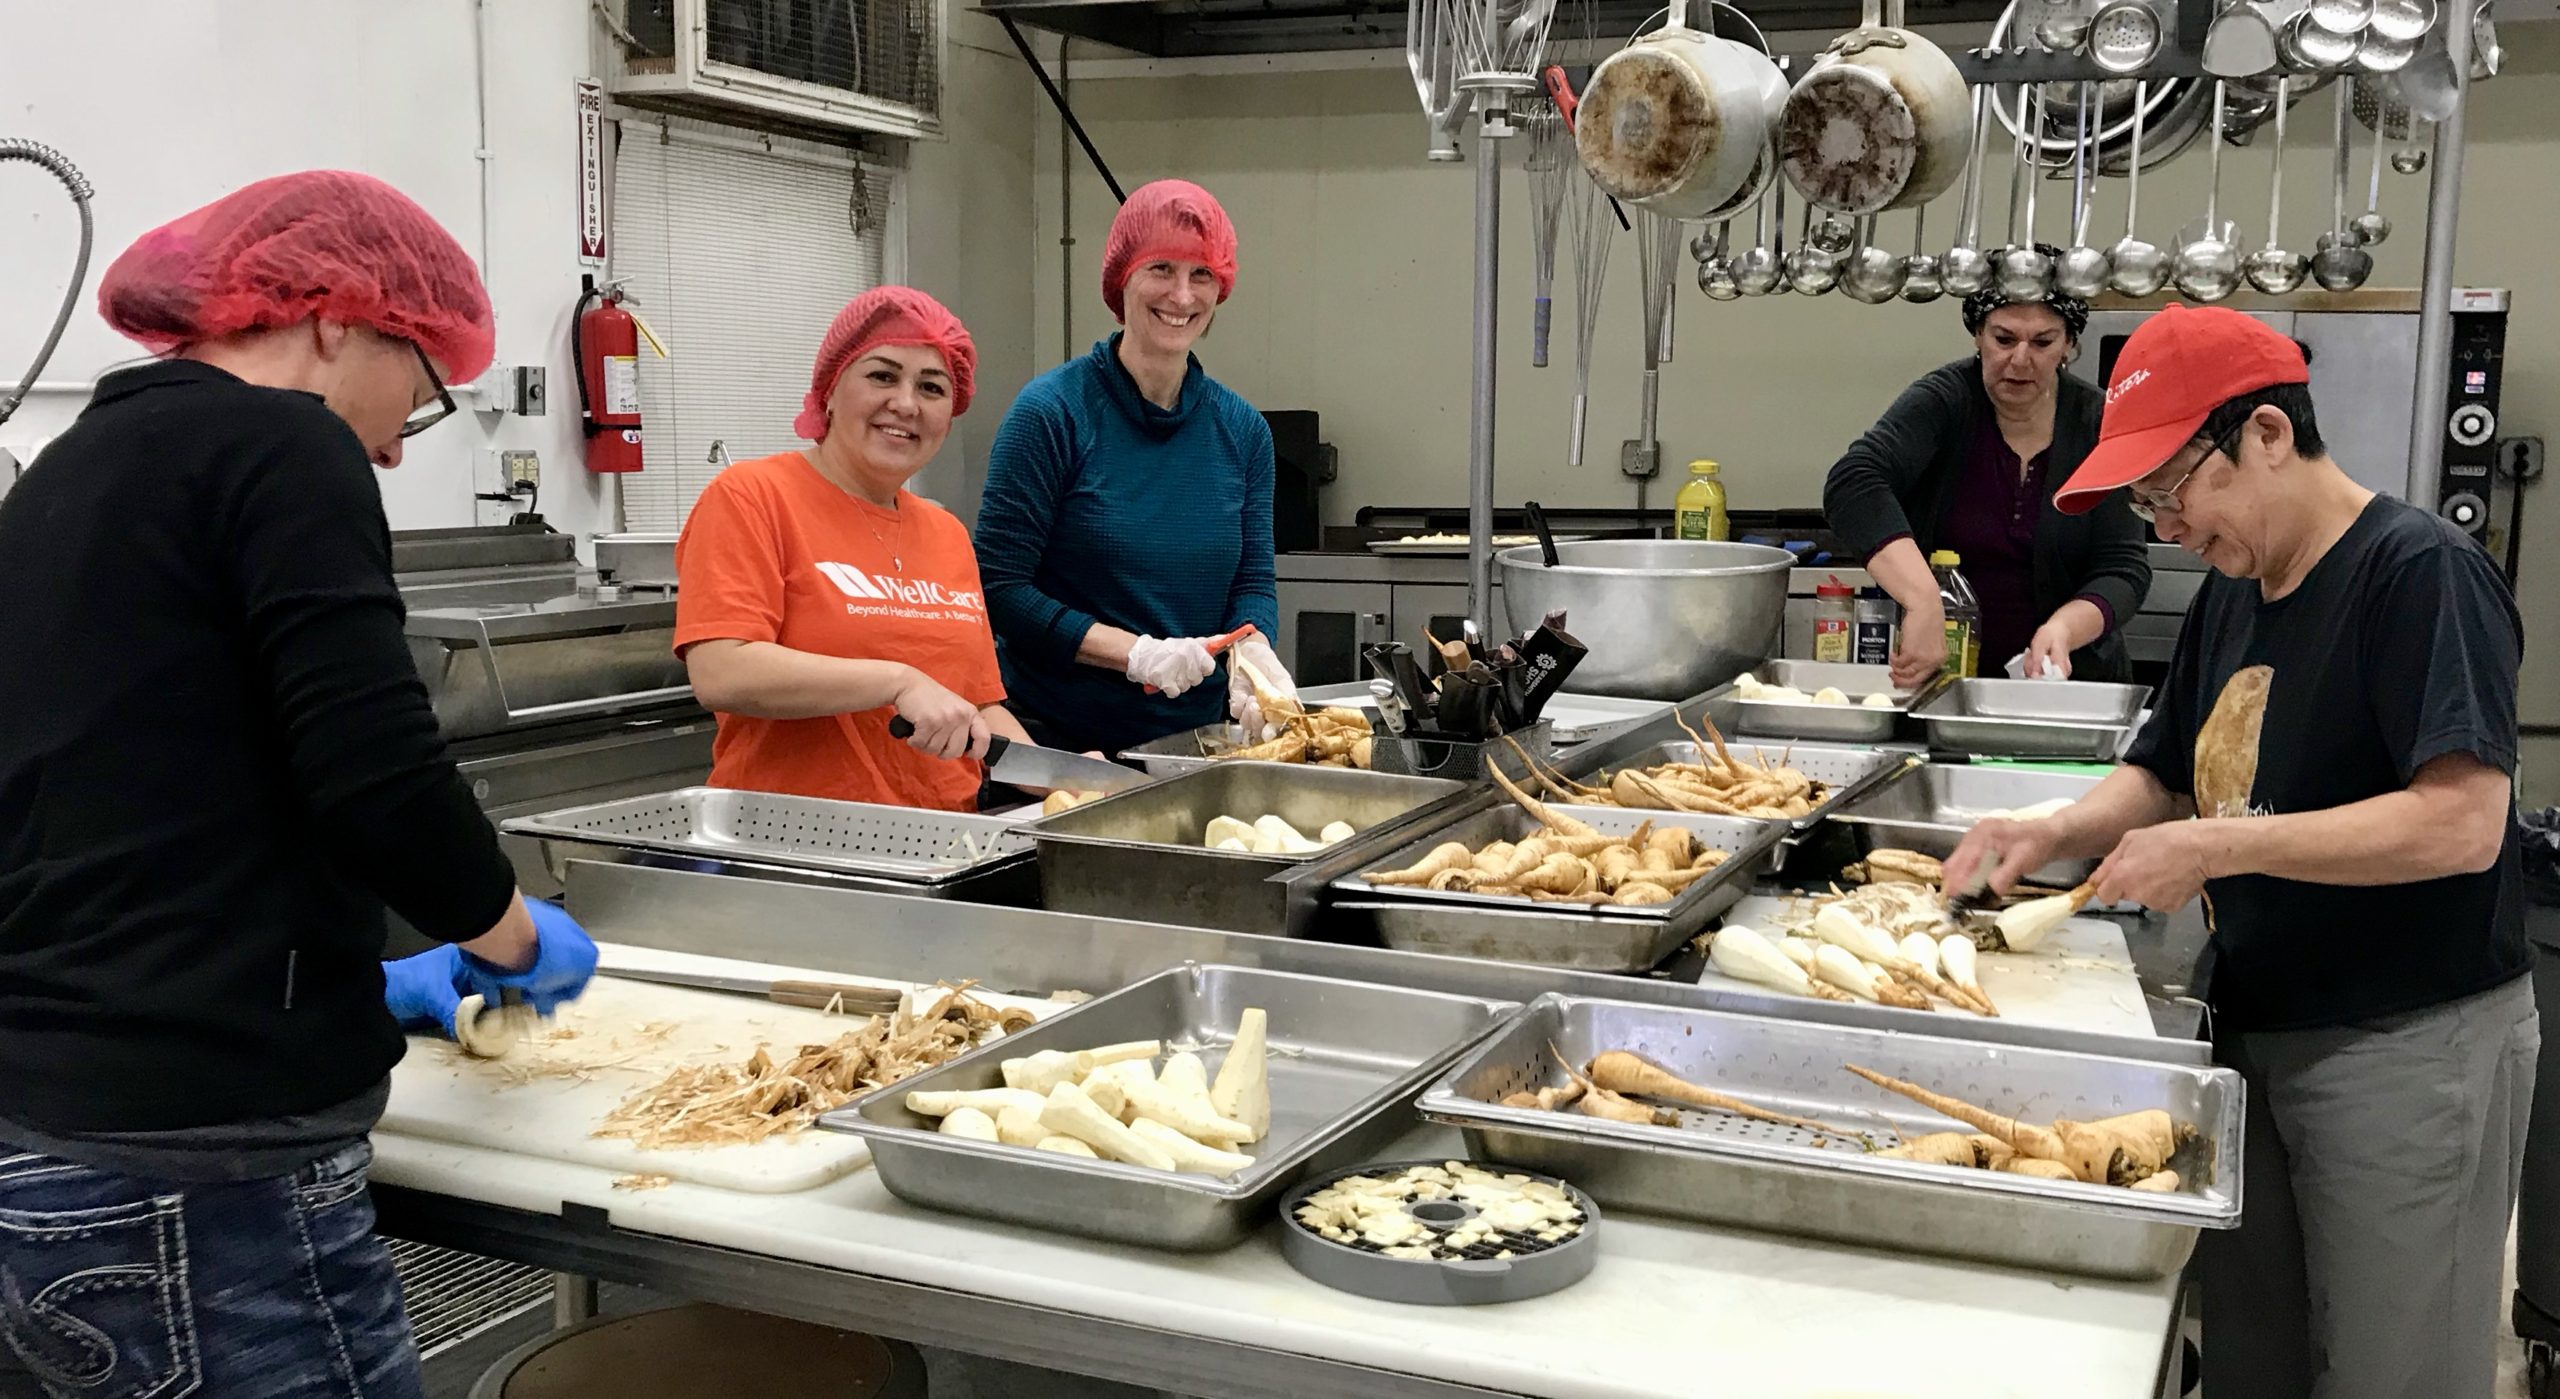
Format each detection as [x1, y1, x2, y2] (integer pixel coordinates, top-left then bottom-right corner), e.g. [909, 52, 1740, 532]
[1823, 356, 2150, 679]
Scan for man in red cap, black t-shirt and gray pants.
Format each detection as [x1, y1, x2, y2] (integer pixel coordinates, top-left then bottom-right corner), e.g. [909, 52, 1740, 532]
[1946, 307, 2540, 1399]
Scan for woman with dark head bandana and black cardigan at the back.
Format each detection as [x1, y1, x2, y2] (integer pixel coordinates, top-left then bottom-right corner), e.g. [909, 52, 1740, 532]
[1823, 257, 2150, 687]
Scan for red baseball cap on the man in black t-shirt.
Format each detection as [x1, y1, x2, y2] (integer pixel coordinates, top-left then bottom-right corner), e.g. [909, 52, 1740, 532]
[2053, 305, 2312, 515]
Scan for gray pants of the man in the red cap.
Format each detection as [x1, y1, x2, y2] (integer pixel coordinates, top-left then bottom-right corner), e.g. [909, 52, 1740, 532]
[2199, 976, 2542, 1399]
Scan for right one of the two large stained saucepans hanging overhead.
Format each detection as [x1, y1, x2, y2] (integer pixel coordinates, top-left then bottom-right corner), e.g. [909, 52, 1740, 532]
[1777, 0, 1974, 215]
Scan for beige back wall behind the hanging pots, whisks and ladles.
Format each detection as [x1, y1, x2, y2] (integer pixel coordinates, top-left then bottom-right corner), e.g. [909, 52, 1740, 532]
[1032, 38, 2560, 799]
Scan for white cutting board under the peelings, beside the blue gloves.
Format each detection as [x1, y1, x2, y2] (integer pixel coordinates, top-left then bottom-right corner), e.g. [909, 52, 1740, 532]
[381, 951, 1065, 1194]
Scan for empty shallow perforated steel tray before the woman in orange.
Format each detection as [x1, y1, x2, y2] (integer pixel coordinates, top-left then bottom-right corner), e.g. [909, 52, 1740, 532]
[502, 787, 1032, 894]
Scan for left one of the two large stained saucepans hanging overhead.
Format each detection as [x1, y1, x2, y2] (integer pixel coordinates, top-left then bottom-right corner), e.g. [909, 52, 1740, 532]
[1574, 0, 1784, 218]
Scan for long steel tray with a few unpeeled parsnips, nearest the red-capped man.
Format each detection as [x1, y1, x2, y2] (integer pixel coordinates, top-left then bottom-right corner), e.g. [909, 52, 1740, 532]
[1421, 994, 2243, 1279]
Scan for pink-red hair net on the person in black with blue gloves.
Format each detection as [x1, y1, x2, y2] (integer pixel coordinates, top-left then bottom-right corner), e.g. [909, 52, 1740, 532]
[97, 169, 497, 382]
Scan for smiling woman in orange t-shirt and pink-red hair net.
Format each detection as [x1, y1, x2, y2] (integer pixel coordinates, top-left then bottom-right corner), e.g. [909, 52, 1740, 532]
[676, 287, 1027, 812]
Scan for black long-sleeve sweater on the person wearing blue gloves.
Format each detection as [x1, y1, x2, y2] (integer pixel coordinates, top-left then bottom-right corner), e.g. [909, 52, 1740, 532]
[0, 361, 515, 1133]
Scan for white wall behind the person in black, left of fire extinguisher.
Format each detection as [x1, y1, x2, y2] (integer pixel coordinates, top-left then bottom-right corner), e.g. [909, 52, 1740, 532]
[0, 0, 609, 533]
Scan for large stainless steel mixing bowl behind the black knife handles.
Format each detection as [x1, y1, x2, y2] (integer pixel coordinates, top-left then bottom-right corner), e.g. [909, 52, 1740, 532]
[1495, 538, 1795, 700]
